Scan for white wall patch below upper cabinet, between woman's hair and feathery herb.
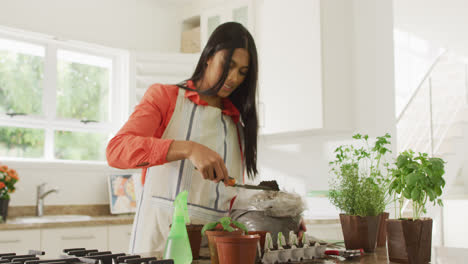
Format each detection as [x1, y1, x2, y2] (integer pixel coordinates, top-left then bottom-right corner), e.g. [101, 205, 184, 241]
[257, 130, 351, 195]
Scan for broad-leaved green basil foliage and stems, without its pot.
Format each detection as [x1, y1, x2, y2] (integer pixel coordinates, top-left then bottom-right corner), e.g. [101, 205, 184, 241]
[389, 150, 445, 220]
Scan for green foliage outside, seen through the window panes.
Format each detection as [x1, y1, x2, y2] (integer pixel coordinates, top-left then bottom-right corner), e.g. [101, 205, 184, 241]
[0, 47, 110, 160]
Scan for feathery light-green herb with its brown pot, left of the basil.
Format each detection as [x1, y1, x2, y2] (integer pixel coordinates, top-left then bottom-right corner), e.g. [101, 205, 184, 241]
[328, 134, 391, 252]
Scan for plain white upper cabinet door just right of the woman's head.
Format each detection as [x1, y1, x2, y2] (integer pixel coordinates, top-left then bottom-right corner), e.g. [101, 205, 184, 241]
[256, 0, 323, 134]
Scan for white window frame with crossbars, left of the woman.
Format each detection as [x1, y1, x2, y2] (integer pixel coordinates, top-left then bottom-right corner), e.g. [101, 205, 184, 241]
[0, 26, 130, 164]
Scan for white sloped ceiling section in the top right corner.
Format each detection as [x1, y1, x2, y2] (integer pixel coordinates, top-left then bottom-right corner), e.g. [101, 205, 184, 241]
[394, 0, 468, 57]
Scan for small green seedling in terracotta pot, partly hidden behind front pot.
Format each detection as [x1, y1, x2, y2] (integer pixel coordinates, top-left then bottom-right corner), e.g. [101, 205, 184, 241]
[201, 217, 248, 264]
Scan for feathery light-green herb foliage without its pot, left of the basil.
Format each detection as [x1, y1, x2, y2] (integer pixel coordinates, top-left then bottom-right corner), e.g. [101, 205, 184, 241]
[328, 133, 392, 216]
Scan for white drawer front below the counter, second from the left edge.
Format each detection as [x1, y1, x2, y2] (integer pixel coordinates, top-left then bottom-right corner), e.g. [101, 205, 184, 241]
[41, 226, 107, 257]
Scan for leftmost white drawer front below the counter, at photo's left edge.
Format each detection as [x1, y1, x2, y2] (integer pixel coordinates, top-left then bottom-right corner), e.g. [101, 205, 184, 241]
[0, 229, 41, 254]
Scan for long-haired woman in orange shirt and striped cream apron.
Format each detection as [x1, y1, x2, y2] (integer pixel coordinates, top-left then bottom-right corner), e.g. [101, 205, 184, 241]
[107, 22, 258, 253]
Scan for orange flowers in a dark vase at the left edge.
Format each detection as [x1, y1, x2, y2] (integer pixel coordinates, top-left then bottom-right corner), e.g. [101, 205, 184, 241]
[0, 165, 19, 222]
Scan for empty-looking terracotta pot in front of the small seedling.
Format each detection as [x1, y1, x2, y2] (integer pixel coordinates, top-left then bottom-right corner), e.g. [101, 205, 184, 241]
[215, 235, 260, 264]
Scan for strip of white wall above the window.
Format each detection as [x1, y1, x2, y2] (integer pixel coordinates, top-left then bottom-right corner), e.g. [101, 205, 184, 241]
[0, 0, 181, 52]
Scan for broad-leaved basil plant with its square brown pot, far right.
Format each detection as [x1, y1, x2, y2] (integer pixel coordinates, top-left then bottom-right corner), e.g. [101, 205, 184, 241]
[387, 150, 445, 263]
